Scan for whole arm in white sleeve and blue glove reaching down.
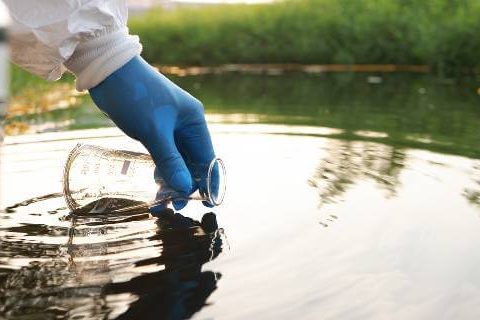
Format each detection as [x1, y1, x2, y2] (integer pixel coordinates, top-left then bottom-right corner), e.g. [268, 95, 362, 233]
[5, 0, 215, 209]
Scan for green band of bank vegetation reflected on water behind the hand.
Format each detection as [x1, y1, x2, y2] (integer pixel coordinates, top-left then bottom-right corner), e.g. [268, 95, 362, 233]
[11, 72, 480, 159]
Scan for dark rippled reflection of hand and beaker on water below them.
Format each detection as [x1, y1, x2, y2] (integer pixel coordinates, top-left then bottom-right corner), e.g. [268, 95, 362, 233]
[0, 194, 223, 319]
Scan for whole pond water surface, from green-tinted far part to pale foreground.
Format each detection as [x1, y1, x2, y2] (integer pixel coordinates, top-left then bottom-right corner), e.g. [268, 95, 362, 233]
[0, 74, 480, 319]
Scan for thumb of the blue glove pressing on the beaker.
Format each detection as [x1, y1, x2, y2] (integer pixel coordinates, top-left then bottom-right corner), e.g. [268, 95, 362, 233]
[145, 107, 192, 196]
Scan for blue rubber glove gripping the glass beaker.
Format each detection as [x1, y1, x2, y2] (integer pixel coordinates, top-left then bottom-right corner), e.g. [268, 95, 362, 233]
[89, 56, 215, 213]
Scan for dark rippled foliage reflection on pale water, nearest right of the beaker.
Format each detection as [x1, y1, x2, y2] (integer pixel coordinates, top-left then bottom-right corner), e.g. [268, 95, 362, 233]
[309, 140, 406, 204]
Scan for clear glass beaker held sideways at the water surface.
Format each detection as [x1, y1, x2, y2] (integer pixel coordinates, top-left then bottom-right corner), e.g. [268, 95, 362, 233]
[63, 144, 226, 213]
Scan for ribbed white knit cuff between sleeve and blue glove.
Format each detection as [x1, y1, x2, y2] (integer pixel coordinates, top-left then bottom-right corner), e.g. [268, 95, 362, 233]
[65, 28, 142, 91]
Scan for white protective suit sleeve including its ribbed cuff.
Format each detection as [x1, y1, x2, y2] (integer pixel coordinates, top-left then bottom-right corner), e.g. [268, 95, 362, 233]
[0, 0, 142, 91]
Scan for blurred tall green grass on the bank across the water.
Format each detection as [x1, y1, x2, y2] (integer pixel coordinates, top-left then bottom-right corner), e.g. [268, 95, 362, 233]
[129, 0, 480, 75]
